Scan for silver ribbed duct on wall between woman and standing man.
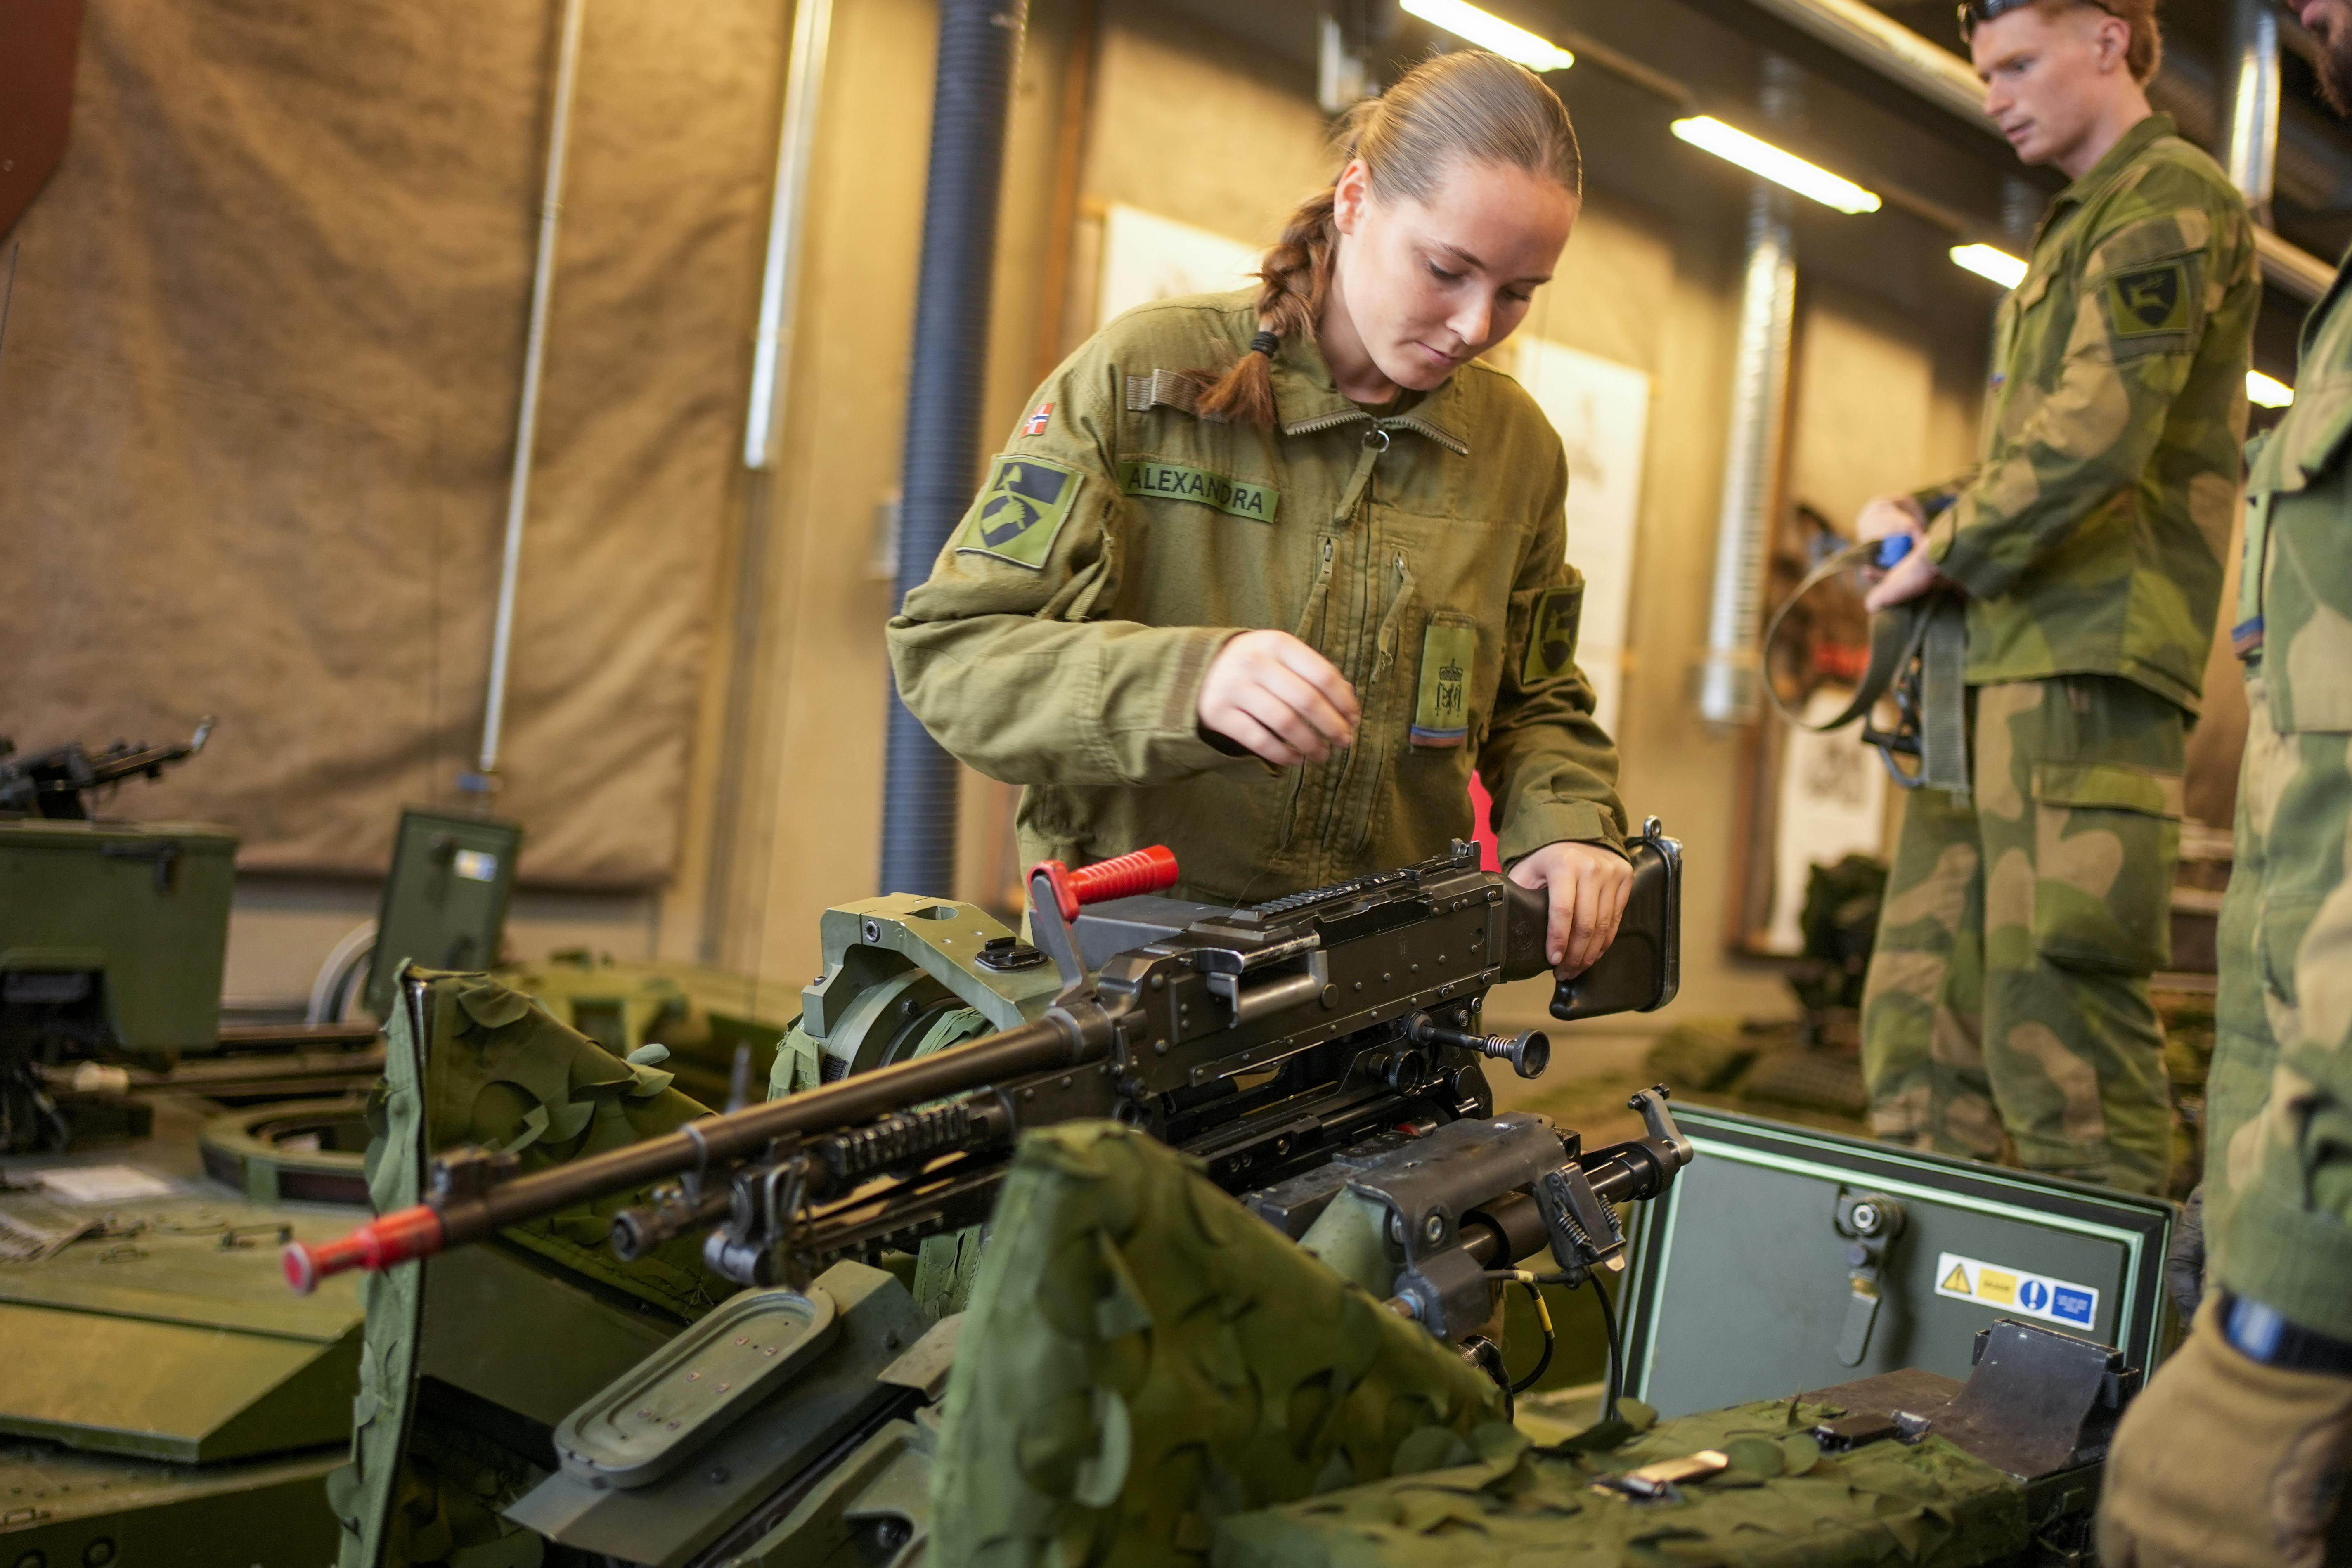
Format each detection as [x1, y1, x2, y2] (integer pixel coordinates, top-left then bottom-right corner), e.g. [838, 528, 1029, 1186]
[1696, 181, 1797, 729]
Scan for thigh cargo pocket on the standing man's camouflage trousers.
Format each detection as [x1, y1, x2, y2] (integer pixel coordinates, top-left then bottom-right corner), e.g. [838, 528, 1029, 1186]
[2032, 762, 2180, 976]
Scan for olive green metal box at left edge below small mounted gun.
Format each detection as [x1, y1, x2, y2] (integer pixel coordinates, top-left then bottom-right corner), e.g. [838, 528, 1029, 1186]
[0, 816, 237, 1055]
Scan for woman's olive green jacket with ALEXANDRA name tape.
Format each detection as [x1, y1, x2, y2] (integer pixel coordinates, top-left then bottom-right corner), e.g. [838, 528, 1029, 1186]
[889, 294, 1625, 903]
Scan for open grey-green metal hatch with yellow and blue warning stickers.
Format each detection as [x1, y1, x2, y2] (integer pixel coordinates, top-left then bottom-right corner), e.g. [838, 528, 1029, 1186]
[1625, 1105, 2176, 1415]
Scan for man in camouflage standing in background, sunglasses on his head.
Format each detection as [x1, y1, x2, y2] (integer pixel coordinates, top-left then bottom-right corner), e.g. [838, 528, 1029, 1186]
[1860, 0, 2260, 1192]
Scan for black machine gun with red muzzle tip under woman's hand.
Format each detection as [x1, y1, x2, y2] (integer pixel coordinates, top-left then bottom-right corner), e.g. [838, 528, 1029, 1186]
[284, 818, 1689, 1298]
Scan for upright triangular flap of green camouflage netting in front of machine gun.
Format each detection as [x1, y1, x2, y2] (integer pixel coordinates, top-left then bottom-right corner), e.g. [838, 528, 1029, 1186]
[931, 1121, 1510, 1568]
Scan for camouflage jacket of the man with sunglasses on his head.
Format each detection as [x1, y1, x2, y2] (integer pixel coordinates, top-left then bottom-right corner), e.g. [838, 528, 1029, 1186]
[1921, 115, 2260, 712]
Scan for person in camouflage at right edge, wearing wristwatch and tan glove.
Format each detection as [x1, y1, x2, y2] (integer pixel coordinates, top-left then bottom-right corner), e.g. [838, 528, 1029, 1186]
[2100, 0, 2352, 1568]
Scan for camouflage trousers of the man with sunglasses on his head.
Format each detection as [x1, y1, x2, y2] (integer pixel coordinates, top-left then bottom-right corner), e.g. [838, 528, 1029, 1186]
[1863, 675, 2187, 1192]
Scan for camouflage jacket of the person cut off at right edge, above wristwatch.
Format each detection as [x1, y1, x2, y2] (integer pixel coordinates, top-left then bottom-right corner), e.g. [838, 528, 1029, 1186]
[2206, 251, 2352, 1340]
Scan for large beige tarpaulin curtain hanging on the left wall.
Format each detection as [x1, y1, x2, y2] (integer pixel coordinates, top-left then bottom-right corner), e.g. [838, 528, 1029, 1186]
[0, 0, 788, 886]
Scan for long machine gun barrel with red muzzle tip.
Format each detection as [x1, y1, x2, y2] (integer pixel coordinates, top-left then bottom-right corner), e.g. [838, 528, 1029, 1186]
[284, 1011, 1108, 1295]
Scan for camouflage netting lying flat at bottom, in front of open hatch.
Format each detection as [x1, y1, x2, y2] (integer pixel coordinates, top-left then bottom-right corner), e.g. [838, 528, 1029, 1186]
[1211, 1399, 2028, 1568]
